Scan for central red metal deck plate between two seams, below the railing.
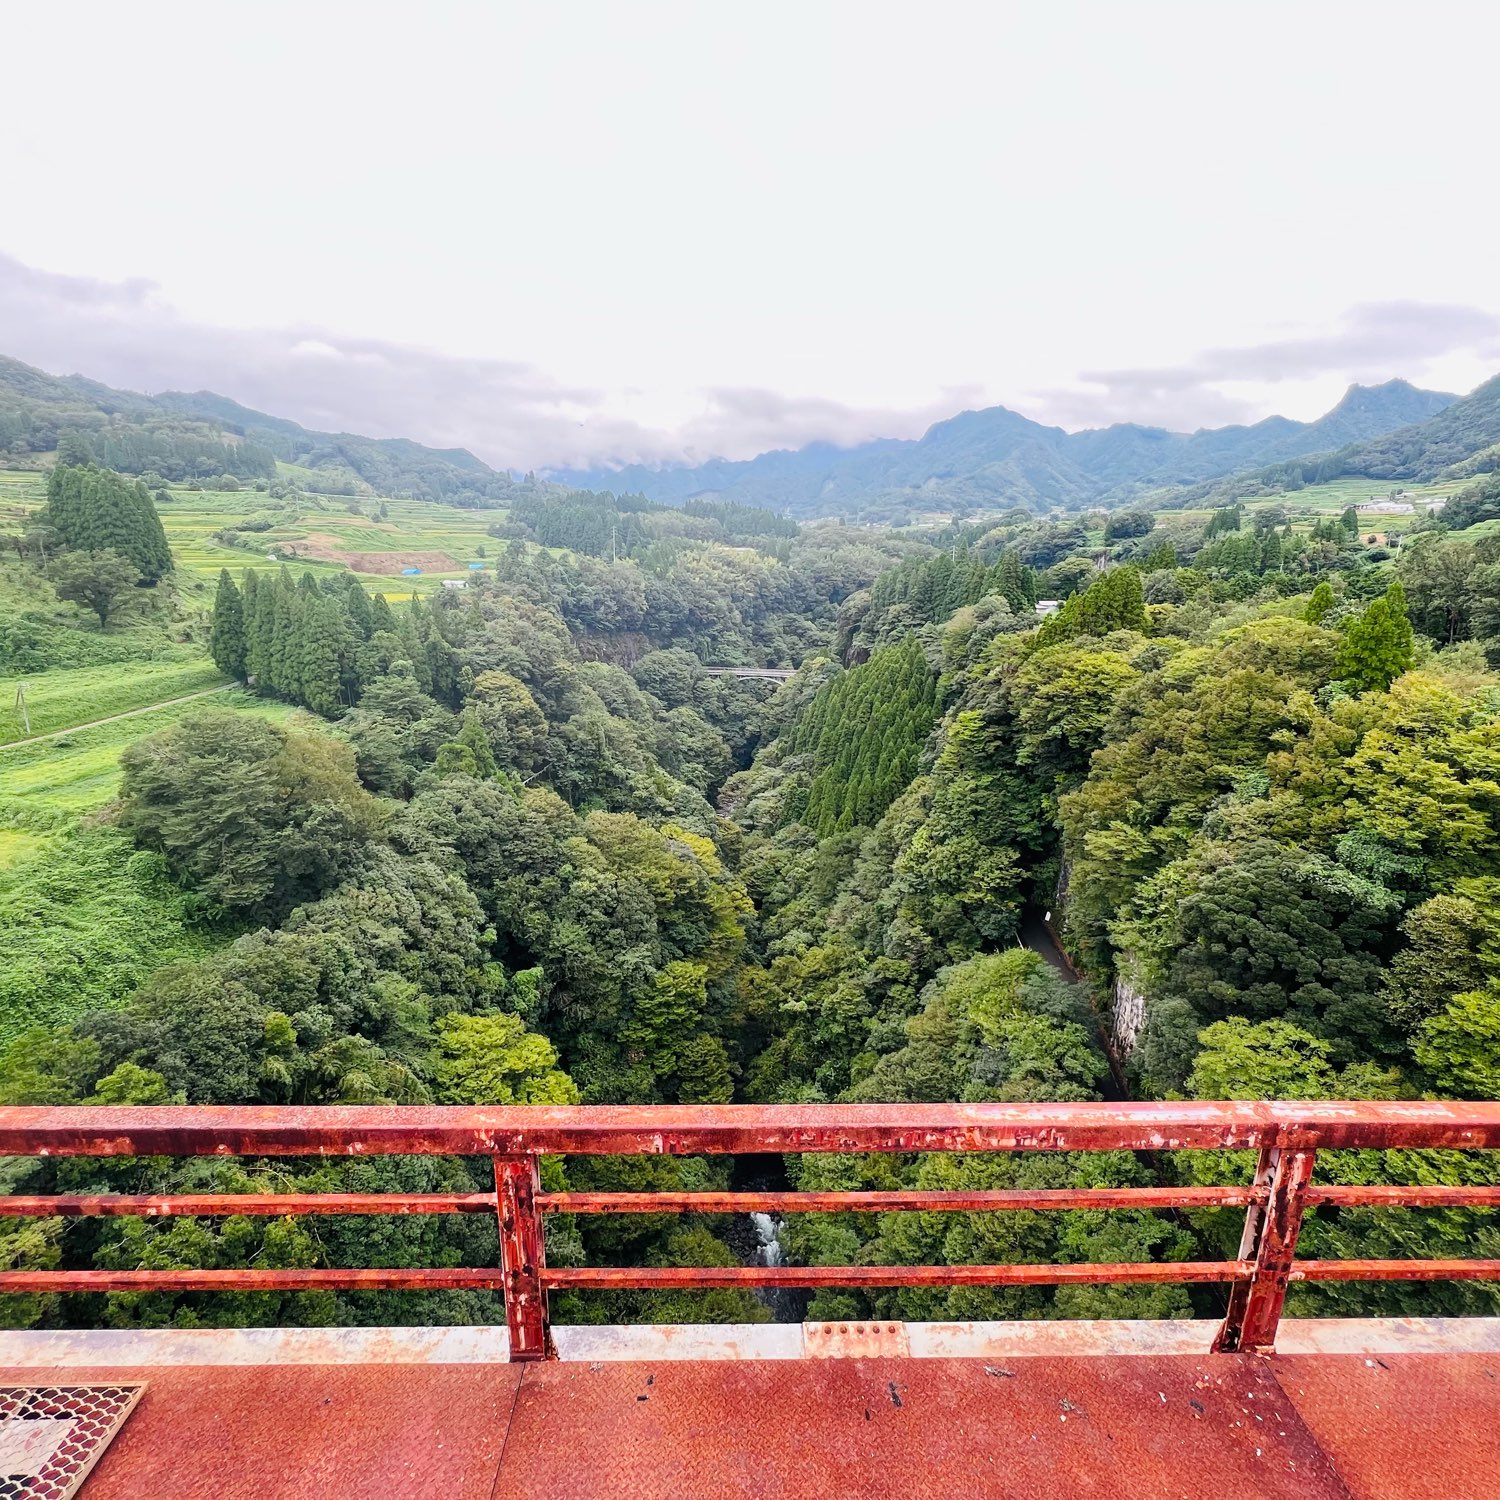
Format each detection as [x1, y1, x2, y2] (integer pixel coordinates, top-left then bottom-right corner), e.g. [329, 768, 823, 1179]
[495, 1355, 1350, 1500]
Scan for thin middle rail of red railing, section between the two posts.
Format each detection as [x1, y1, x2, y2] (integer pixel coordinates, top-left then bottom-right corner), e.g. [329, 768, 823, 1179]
[537, 1188, 1266, 1214]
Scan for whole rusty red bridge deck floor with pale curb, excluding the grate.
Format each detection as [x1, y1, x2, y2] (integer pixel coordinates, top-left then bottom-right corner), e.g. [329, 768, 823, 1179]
[0, 1331, 1500, 1500]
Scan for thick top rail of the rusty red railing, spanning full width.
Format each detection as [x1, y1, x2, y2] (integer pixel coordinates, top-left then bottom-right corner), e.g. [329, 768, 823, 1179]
[0, 1100, 1500, 1157]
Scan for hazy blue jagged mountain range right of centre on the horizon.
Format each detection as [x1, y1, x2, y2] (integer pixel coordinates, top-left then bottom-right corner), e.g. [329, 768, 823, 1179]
[551, 380, 1464, 516]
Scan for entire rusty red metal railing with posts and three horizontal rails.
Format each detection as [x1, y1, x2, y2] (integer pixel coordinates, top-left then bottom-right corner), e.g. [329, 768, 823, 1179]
[0, 1101, 1500, 1359]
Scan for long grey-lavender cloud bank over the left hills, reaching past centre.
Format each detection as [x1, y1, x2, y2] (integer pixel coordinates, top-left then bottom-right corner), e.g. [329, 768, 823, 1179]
[0, 255, 975, 468]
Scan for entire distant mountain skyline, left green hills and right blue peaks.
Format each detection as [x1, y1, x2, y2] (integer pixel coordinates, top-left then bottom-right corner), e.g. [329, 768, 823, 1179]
[0, 356, 1500, 521]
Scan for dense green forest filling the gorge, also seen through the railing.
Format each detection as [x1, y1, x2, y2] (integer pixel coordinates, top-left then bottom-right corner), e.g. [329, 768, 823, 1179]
[0, 471, 1500, 1326]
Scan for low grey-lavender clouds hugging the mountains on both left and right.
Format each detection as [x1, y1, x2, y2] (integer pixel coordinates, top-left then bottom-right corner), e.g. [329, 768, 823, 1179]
[0, 254, 1500, 470]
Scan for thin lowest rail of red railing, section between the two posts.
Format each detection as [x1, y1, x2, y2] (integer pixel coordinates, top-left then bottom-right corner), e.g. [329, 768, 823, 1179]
[542, 1260, 1254, 1289]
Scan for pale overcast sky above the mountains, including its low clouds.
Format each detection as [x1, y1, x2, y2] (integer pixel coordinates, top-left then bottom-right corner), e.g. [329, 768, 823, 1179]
[0, 0, 1500, 468]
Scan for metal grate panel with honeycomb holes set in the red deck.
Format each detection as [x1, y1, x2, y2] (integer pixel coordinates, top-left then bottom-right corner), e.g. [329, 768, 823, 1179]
[0, 1382, 146, 1500]
